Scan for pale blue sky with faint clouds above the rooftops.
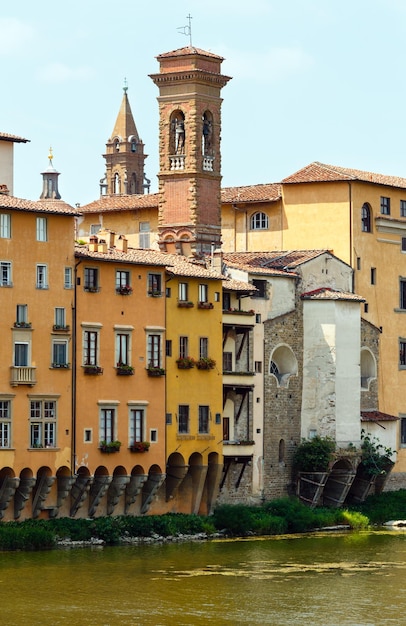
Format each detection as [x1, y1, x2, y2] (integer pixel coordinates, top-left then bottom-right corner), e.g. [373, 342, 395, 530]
[0, 0, 406, 205]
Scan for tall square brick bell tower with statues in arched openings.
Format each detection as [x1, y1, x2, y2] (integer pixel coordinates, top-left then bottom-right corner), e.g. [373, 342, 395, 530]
[150, 46, 230, 256]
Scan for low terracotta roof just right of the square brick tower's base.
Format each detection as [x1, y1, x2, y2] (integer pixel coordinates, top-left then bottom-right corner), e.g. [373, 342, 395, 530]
[223, 250, 328, 276]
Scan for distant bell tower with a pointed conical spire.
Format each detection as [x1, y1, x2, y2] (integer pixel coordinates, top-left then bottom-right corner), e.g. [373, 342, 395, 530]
[100, 85, 149, 196]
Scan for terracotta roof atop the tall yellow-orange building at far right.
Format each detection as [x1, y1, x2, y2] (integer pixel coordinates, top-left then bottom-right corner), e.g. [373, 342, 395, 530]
[282, 161, 406, 189]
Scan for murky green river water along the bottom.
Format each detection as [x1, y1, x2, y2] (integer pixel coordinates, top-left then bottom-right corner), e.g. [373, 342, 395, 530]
[0, 531, 406, 626]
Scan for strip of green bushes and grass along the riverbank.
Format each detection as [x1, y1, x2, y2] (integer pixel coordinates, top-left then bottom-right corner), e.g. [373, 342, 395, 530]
[0, 490, 406, 550]
